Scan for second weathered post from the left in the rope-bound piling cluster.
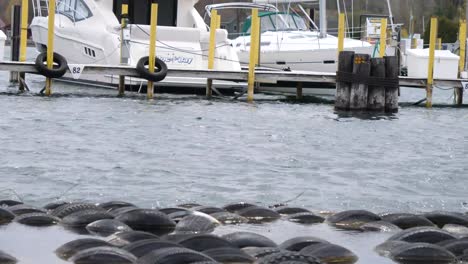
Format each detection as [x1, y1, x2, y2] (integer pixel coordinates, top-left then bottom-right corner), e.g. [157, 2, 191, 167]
[349, 54, 370, 110]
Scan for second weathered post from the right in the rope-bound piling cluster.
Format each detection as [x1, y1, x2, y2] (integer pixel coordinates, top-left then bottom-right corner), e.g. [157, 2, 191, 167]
[367, 58, 385, 111]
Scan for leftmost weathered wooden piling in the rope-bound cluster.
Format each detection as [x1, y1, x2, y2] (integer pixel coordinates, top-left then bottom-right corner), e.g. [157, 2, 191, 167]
[335, 51, 354, 110]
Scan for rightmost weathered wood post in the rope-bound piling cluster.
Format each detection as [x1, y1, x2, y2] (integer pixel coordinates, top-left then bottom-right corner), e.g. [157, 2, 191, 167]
[385, 56, 400, 113]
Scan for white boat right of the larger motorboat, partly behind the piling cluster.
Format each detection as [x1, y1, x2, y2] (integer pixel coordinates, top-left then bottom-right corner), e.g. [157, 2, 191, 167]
[205, 0, 394, 95]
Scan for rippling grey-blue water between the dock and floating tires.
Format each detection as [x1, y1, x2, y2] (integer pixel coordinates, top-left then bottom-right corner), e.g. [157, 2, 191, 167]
[0, 48, 468, 263]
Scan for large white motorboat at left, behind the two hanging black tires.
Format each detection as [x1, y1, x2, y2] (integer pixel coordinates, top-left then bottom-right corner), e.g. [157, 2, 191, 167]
[31, 0, 245, 92]
